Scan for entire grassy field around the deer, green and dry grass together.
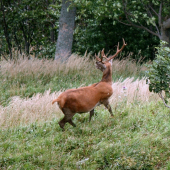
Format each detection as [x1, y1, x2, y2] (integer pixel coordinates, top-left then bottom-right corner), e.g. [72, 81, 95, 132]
[0, 55, 170, 170]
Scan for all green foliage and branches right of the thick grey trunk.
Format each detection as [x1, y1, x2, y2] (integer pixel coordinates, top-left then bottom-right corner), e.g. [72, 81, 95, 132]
[74, 0, 170, 59]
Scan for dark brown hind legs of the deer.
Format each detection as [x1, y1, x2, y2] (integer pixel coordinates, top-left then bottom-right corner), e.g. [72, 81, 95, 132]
[59, 108, 76, 129]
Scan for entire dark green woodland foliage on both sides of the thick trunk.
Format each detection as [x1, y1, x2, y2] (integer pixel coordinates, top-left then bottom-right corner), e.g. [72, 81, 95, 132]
[0, 0, 170, 60]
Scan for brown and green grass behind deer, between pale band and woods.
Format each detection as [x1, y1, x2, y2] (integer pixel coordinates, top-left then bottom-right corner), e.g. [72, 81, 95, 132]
[0, 55, 146, 105]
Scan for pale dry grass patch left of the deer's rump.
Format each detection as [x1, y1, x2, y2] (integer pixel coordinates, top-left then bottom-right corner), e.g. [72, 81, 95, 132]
[0, 90, 61, 128]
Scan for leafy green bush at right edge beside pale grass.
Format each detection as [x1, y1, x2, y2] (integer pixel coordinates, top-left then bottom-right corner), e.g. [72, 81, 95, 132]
[147, 42, 170, 106]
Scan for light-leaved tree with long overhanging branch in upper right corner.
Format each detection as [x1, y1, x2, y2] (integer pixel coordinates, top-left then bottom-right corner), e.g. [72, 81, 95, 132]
[75, 0, 170, 44]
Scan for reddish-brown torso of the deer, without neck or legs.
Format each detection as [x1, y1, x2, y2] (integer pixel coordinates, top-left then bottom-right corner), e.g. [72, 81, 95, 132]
[57, 84, 112, 113]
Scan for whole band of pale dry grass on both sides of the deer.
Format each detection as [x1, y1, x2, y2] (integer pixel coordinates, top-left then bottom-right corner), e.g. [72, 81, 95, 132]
[0, 78, 158, 128]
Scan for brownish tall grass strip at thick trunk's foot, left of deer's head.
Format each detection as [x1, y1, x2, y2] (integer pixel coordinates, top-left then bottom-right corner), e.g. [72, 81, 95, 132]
[0, 55, 93, 78]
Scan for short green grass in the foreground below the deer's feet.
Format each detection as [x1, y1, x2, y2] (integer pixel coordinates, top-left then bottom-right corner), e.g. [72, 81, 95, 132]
[0, 102, 170, 170]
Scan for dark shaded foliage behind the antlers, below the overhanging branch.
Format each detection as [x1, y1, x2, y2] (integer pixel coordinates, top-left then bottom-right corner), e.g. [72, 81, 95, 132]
[73, 18, 159, 60]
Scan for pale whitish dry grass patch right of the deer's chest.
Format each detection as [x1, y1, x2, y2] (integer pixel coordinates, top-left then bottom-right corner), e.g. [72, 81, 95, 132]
[110, 78, 159, 107]
